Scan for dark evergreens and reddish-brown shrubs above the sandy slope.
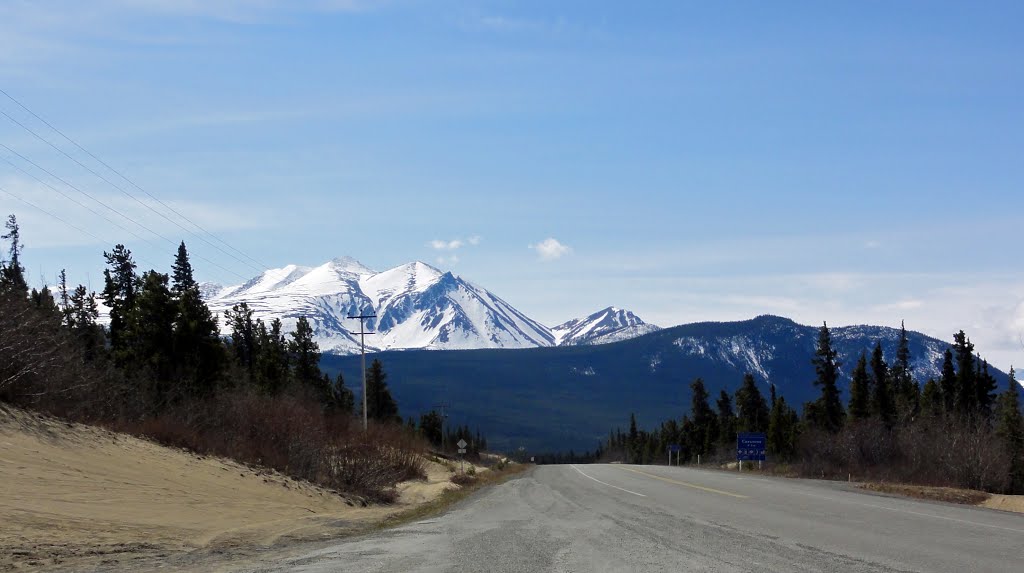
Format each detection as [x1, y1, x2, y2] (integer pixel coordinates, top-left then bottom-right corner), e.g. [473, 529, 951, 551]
[0, 215, 485, 500]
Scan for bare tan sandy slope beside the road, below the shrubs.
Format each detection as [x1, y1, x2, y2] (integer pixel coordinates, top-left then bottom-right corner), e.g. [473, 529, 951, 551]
[0, 406, 451, 571]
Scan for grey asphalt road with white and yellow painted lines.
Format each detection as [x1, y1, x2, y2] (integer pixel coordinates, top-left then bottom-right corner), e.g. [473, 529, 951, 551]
[247, 465, 1024, 573]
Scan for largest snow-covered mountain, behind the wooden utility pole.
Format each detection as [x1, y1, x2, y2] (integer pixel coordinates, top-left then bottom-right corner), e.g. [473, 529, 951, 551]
[203, 257, 555, 354]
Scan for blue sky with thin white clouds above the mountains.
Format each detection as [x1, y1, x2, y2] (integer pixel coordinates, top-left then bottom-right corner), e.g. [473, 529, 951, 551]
[0, 0, 1024, 368]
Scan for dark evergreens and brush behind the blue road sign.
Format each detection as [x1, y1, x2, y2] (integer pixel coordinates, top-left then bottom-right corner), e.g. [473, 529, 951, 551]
[595, 324, 1024, 492]
